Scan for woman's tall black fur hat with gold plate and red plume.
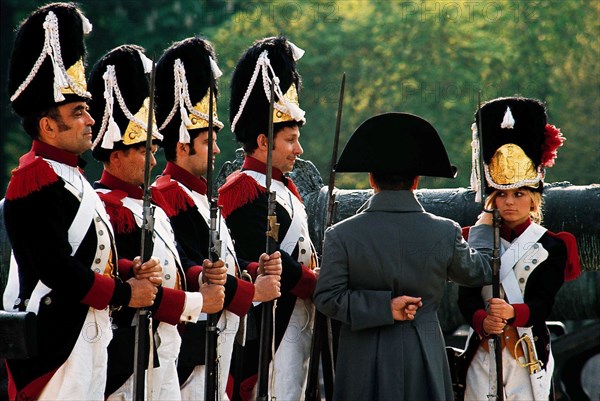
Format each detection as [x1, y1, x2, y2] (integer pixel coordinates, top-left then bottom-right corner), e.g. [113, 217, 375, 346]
[471, 97, 565, 199]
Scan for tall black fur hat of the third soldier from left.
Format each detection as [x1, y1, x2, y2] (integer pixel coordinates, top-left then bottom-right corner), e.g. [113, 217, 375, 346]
[155, 37, 223, 145]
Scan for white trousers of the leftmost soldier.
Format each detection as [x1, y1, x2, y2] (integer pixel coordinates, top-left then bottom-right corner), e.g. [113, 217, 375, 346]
[39, 308, 112, 401]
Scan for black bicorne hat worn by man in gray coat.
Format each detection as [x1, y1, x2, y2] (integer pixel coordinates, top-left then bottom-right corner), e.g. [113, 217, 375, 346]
[335, 112, 456, 178]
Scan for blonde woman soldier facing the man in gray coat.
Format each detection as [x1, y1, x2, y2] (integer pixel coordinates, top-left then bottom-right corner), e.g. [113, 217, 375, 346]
[458, 98, 580, 401]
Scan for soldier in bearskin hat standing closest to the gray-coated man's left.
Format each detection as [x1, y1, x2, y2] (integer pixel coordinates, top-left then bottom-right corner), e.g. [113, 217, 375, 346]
[219, 37, 317, 400]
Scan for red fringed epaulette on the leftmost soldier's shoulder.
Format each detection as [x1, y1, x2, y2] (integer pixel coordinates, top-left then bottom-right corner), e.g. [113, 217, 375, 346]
[6, 152, 60, 200]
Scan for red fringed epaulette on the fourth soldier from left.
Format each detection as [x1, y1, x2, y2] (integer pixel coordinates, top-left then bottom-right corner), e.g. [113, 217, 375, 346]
[218, 171, 266, 218]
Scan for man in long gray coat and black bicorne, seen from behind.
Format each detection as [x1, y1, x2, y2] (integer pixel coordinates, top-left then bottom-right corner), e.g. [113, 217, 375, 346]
[314, 113, 492, 401]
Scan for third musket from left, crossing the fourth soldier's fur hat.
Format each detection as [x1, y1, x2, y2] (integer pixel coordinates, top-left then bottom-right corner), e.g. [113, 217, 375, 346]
[256, 80, 279, 401]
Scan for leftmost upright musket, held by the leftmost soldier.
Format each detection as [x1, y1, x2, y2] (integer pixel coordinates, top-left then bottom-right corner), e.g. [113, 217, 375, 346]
[133, 60, 156, 401]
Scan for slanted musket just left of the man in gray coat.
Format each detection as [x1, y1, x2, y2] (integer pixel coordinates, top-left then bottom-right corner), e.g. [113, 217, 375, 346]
[305, 73, 346, 401]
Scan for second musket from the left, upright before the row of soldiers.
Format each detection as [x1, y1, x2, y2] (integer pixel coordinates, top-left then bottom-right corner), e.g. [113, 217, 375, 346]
[204, 73, 222, 401]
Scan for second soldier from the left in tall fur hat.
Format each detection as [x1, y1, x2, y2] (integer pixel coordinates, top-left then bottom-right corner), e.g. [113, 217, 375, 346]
[89, 45, 225, 400]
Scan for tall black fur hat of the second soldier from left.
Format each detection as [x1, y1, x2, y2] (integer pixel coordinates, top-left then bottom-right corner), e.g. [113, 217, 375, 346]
[89, 45, 162, 161]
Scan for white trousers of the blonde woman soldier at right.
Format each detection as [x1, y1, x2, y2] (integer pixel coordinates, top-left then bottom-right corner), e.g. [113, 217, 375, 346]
[465, 346, 534, 401]
